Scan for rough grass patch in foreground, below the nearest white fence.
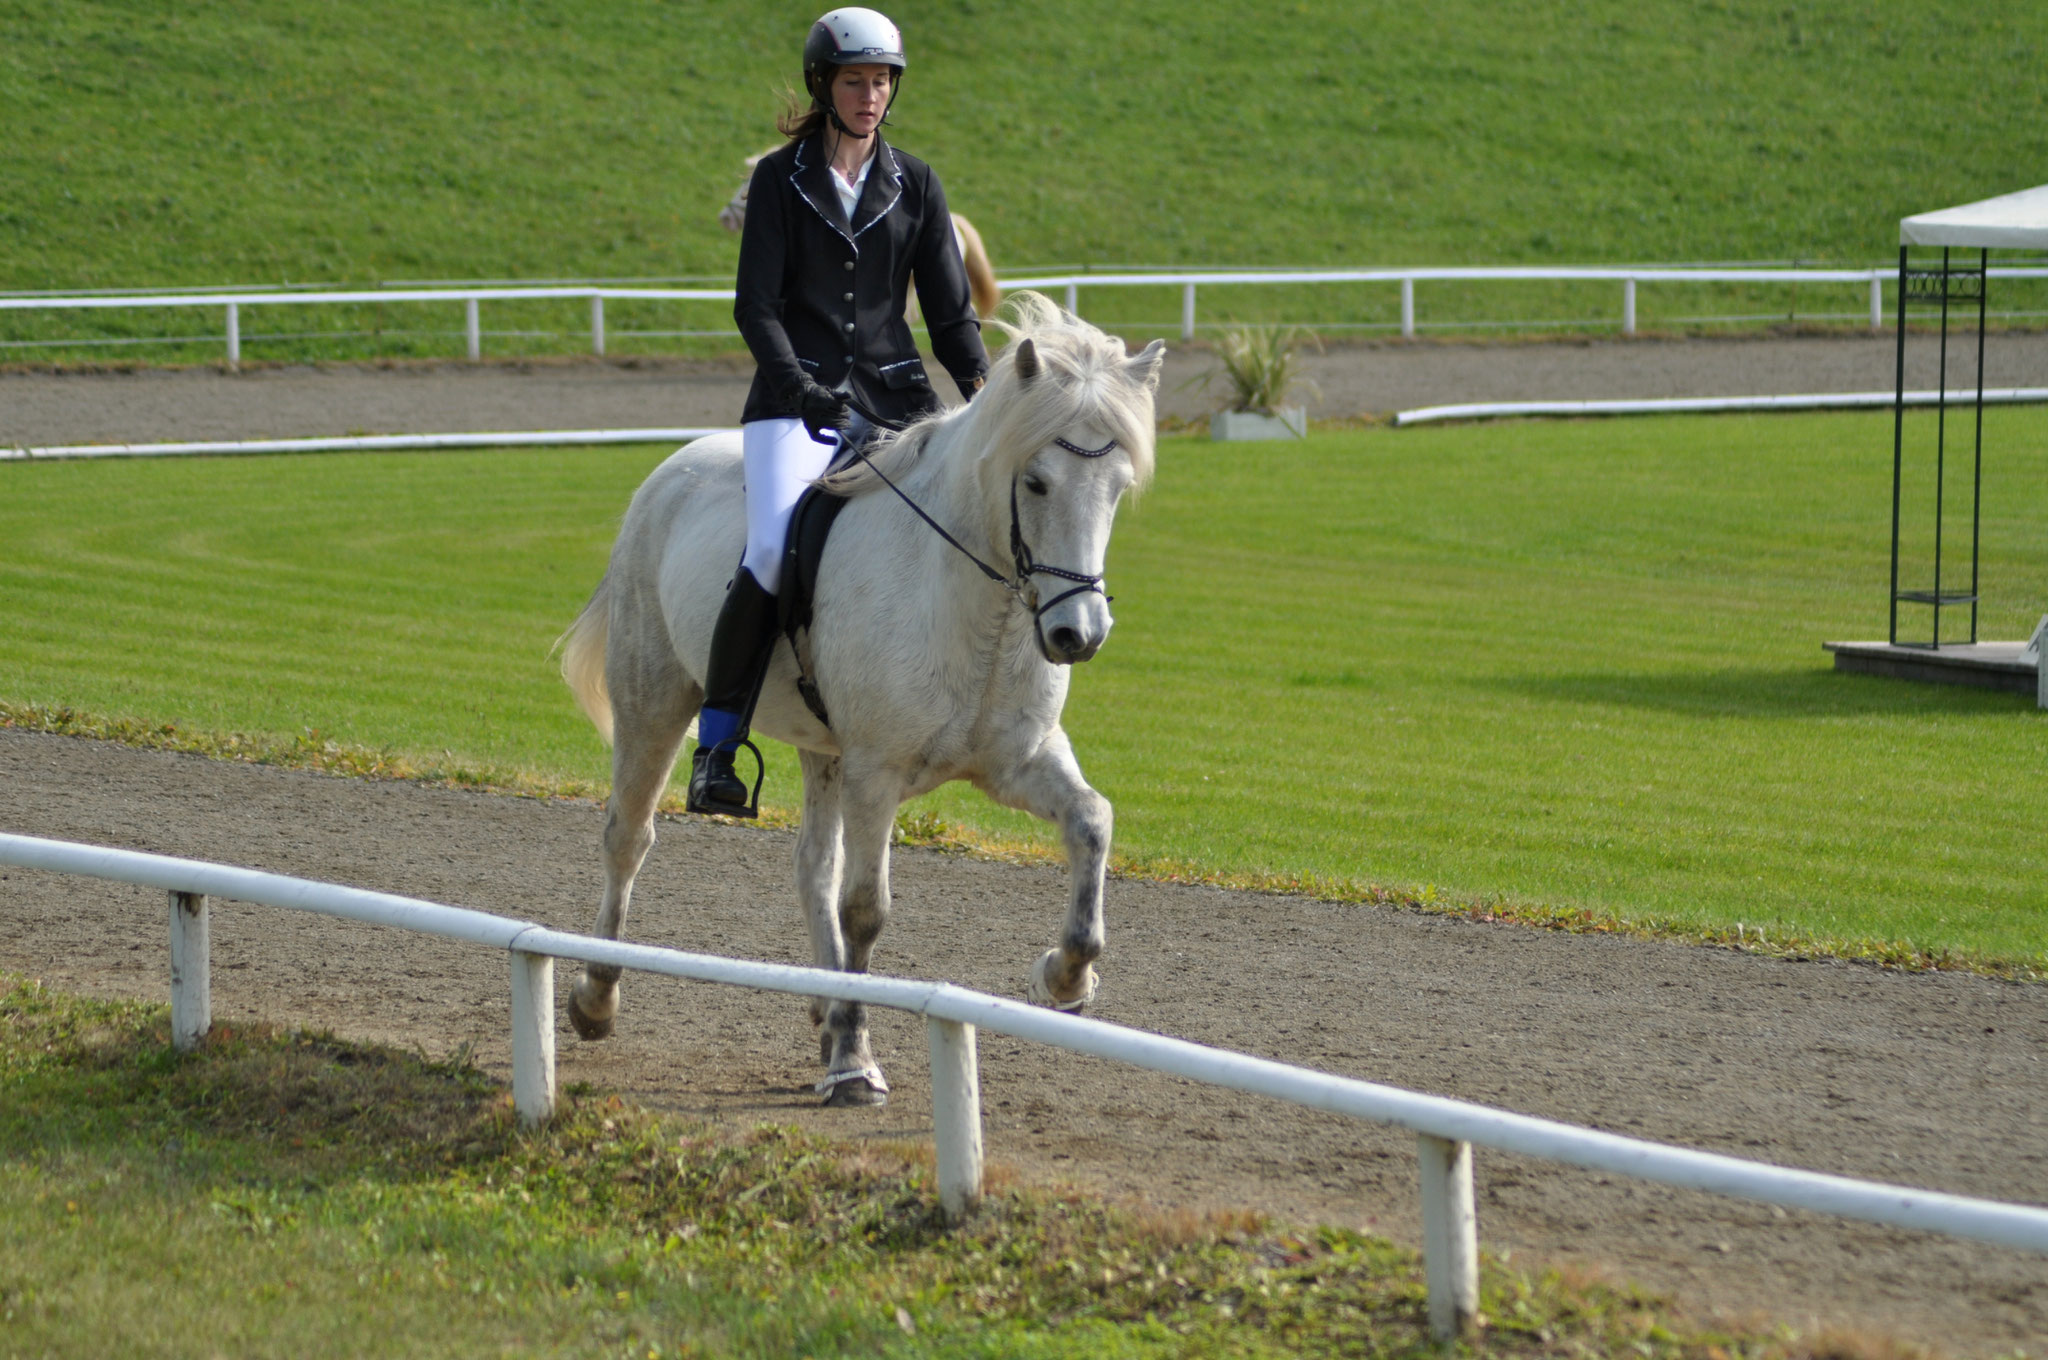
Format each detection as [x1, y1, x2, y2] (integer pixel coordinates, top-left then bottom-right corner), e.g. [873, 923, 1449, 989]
[0, 975, 1761, 1360]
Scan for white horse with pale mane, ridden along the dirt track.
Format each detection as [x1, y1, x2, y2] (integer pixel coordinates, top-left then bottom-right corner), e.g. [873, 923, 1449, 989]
[561, 293, 1165, 1104]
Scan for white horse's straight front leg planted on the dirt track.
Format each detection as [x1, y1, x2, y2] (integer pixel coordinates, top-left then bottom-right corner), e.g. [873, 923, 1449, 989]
[811, 762, 903, 1106]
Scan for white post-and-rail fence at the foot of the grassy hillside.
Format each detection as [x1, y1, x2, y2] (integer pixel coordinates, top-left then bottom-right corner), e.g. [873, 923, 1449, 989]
[12, 264, 2048, 365]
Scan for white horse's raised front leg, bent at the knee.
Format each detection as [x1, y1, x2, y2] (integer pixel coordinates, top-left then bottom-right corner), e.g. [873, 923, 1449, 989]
[983, 729, 1114, 1010]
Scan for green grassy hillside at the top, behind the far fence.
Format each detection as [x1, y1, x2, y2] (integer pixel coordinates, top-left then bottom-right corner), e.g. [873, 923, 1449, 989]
[0, 0, 2048, 360]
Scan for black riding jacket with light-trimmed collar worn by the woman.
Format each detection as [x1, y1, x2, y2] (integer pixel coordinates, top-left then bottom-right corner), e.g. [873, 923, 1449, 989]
[733, 133, 989, 422]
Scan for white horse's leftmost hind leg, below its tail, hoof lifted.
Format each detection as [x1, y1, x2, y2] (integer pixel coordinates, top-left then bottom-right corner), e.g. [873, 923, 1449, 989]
[569, 668, 702, 1038]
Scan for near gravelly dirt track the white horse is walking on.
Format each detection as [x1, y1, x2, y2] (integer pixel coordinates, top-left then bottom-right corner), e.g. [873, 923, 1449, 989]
[0, 729, 2048, 1356]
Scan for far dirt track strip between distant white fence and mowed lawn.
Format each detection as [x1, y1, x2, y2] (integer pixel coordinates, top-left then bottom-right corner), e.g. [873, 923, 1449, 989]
[0, 332, 2048, 440]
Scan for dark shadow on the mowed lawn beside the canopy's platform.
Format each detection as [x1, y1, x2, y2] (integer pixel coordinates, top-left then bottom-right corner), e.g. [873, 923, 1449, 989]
[1477, 666, 2036, 717]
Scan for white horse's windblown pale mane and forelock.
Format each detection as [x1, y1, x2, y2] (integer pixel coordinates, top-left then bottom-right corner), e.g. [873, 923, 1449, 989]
[819, 289, 1159, 496]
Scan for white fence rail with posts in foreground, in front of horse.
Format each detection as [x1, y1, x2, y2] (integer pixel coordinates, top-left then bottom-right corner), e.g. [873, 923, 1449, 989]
[0, 834, 2048, 1337]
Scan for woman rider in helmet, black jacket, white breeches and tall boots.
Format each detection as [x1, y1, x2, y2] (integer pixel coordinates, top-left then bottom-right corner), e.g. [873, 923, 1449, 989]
[688, 8, 989, 817]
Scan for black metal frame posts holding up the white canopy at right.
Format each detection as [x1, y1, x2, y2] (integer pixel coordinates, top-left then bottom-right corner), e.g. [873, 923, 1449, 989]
[1890, 246, 1991, 651]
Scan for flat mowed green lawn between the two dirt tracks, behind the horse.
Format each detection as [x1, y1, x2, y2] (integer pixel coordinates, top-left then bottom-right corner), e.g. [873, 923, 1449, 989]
[0, 410, 2048, 967]
